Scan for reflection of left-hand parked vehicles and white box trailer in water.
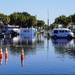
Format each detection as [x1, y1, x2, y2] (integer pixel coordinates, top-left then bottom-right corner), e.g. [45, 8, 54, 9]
[0, 36, 36, 46]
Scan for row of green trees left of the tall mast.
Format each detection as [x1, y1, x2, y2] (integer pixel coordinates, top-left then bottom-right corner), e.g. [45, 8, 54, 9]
[0, 12, 45, 28]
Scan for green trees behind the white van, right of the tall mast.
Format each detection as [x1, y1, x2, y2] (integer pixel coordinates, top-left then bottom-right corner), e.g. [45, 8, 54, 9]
[49, 14, 75, 29]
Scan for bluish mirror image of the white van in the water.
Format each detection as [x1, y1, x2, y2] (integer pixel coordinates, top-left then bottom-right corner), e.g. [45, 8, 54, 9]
[52, 39, 74, 48]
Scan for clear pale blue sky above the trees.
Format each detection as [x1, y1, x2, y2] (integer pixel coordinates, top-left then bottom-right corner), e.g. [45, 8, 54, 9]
[0, 0, 75, 24]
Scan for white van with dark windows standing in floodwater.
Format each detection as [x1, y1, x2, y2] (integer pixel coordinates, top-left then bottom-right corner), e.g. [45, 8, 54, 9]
[51, 28, 74, 39]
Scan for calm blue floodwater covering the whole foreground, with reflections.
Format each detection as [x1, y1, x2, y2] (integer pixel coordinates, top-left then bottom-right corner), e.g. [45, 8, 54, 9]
[0, 35, 75, 74]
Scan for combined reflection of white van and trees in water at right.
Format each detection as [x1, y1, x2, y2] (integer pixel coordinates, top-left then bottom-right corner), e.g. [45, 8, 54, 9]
[52, 39, 75, 58]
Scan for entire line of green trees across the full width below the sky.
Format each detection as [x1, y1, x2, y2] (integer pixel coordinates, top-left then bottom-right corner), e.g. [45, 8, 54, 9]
[0, 12, 75, 29]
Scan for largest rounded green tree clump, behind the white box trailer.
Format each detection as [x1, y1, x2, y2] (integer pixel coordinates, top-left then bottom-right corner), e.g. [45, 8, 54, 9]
[10, 12, 36, 27]
